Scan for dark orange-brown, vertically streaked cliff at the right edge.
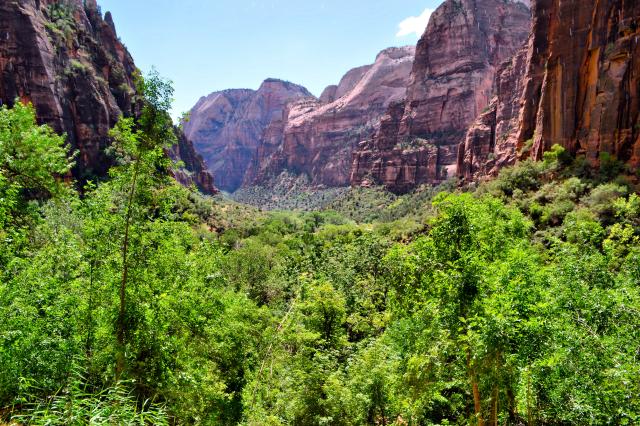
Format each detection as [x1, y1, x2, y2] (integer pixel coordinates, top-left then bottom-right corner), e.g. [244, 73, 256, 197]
[519, 0, 640, 168]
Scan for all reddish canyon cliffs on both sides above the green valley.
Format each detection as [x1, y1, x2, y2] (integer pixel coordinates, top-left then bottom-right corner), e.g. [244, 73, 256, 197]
[0, 0, 640, 194]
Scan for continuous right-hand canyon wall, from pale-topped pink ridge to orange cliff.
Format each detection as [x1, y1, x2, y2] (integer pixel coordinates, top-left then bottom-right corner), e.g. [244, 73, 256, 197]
[190, 0, 640, 193]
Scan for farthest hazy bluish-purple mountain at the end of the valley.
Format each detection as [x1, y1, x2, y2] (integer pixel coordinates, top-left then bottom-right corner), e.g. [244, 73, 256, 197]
[184, 79, 312, 192]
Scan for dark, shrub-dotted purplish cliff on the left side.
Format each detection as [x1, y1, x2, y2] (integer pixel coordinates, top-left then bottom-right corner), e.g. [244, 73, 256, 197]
[0, 0, 216, 193]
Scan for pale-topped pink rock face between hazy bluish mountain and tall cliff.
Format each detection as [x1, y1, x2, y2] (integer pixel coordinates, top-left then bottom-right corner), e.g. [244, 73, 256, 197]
[250, 47, 415, 187]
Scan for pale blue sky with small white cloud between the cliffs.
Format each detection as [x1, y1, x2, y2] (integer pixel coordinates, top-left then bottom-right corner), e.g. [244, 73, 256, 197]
[99, 0, 442, 117]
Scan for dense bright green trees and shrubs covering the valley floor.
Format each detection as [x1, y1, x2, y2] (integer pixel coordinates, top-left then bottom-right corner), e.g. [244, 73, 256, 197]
[0, 75, 640, 425]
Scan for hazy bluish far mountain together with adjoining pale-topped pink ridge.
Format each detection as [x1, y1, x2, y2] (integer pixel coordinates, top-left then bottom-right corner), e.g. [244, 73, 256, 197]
[184, 47, 414, 192]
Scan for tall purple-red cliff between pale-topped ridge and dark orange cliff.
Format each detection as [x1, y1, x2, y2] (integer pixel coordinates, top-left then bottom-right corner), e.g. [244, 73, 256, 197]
[351, 0, 531, 192]
